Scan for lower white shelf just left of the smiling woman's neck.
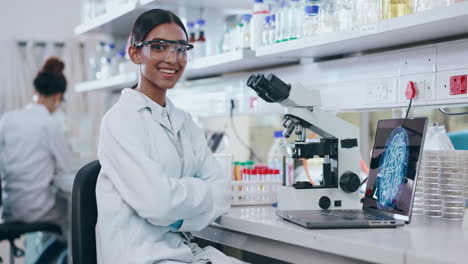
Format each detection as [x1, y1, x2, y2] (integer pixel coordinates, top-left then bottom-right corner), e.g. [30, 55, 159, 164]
[75, 72, 138, 92]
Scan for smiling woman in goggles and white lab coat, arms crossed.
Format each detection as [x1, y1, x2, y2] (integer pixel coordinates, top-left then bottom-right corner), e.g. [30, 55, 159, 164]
[96, 9, 241, 264]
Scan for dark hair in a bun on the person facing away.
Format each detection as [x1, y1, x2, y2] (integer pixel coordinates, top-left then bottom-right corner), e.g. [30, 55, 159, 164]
[34, 57, 67, 96]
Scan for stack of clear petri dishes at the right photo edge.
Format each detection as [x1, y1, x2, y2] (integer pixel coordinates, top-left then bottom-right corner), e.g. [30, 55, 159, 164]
[439, 151, 465, 220]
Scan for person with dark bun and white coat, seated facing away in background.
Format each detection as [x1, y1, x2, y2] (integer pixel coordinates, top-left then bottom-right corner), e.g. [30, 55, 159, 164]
[0, 57, 74, 240]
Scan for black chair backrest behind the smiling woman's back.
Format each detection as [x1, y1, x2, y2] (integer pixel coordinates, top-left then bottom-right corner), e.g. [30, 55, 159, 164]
[71, 160, 101, 264]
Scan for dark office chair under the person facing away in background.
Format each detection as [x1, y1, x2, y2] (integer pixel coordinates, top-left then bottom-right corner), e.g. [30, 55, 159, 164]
[0, 177, 62, 264]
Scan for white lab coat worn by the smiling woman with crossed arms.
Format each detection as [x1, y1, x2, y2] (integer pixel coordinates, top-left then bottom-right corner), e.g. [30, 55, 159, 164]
[96, 89, 233, 264]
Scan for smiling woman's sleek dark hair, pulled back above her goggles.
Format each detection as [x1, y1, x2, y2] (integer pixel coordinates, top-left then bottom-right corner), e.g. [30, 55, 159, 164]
[131, 9, 188, 45]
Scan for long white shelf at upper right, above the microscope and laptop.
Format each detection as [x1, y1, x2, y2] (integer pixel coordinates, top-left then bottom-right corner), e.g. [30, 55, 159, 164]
[256, 2, 468, 58]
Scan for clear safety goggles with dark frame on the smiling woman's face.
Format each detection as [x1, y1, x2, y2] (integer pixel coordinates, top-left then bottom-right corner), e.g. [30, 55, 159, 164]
[134, 39, 193, 62]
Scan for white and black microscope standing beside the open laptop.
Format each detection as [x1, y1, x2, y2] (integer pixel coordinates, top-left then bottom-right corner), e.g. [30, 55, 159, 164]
[247, 73, 362, 210]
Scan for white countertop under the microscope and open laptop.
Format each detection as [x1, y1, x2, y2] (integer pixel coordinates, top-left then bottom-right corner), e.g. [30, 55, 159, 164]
[207, 206, 468, 263]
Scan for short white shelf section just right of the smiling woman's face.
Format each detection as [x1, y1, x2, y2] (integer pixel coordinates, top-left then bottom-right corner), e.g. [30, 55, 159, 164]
[185, 49, 299, 79]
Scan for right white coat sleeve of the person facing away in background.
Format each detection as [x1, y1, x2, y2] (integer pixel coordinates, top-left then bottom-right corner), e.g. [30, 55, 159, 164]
[48, 122, 75, 193]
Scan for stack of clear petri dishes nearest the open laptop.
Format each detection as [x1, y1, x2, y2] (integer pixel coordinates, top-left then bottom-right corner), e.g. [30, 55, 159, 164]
[423, 151, 442, 217]
